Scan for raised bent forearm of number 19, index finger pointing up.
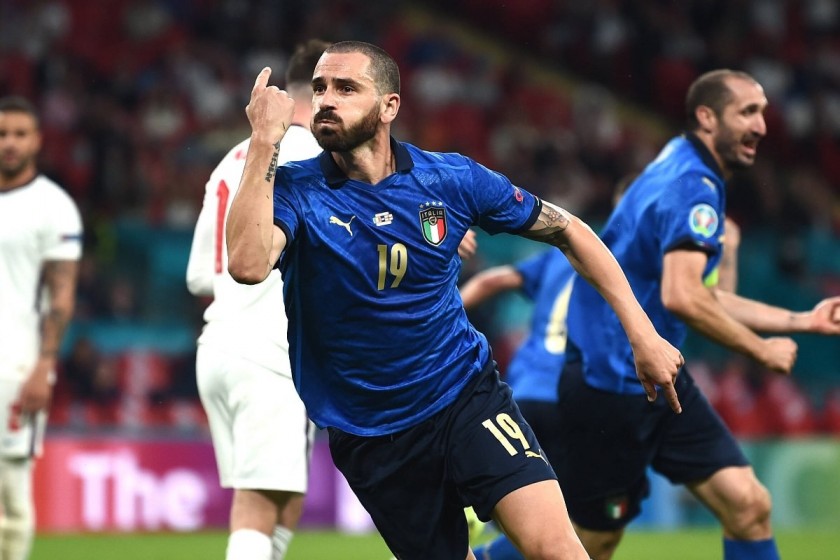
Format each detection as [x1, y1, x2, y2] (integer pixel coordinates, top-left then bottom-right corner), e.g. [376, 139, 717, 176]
[225, 68, 295, 284]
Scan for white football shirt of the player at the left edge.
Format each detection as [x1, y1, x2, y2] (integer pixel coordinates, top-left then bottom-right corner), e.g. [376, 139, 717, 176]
[0, 175, 82, 381]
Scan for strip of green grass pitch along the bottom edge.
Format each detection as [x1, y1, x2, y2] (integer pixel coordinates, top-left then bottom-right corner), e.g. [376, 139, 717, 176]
[30, 529, 840, 560]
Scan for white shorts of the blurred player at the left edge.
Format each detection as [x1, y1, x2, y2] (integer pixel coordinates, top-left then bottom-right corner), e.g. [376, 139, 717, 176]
[0, 379, 47, 459]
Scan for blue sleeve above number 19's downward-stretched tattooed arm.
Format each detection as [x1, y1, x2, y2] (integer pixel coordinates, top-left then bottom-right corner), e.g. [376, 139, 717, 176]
[469, 160, 539, 234]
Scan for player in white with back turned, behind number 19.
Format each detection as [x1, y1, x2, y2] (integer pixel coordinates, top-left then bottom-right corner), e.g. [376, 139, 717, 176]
[187, 40, 329, 560]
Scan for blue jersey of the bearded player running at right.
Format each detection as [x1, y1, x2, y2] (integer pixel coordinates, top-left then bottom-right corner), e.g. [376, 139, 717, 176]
[568, 134, 725, 394]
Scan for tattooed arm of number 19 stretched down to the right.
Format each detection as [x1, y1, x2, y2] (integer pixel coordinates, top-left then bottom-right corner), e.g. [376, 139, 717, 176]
[522, 201, 685, 412]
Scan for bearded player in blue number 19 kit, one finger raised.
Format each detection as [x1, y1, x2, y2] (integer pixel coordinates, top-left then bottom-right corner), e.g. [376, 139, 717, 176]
[227, 41, 683, 560]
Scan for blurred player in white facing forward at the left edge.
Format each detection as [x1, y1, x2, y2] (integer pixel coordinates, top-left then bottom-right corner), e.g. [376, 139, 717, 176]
[0, 97, 82, 560]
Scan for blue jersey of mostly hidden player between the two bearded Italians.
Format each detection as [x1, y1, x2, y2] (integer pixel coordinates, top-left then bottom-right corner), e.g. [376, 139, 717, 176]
[506, 248, 575, 402]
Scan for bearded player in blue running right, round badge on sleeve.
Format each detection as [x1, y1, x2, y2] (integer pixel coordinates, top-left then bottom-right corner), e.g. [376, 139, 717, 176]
[554, 70, 840, 560]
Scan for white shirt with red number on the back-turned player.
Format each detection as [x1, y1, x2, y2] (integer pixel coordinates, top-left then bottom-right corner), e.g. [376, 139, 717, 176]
[187, 125, 322, 377]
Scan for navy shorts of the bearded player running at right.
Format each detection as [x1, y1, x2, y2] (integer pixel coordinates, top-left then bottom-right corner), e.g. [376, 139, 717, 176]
[554, 361, 749, 531]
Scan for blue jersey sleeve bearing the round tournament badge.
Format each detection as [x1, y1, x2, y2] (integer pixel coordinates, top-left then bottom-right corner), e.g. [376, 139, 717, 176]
[657, 173, 723, 253]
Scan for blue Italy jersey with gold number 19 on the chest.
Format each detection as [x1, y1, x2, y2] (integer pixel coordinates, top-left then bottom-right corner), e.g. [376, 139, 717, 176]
[274, 140, 539, 436]
